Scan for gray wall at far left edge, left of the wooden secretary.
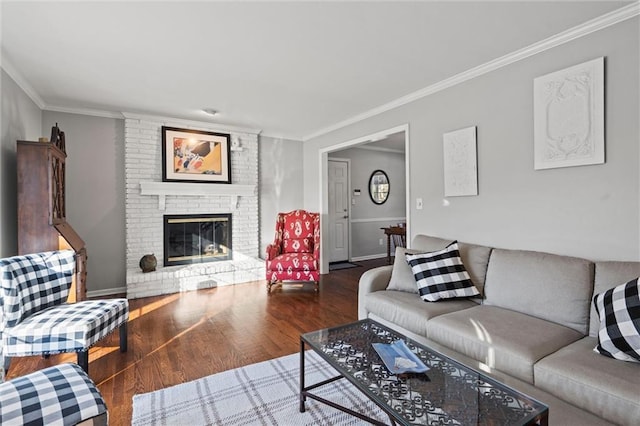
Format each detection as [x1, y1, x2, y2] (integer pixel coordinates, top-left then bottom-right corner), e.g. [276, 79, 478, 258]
[0, 70, 42, 257]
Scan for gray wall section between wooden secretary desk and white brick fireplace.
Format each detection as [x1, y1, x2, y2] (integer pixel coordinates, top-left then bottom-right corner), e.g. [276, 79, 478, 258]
[42, 111, 126, 296]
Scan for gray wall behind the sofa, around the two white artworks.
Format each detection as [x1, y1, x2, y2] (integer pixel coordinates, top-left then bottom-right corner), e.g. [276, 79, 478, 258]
[303, 17, 640, 260]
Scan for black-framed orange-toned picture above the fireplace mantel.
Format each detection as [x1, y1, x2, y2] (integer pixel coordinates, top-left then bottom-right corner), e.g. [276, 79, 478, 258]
[162, 126, 231, 184]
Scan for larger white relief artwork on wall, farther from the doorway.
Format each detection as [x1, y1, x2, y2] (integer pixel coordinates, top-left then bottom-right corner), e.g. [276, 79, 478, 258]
[533, 57, 604, 170]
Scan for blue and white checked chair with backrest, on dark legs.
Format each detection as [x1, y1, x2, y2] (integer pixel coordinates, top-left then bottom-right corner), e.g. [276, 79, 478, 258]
[0, 250, 129, 372]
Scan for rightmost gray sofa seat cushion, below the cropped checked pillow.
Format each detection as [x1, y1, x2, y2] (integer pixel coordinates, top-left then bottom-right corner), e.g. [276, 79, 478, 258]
[534, 337, 640, 425]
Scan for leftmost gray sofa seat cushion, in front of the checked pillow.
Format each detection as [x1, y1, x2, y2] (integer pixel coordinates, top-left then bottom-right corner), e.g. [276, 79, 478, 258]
[364, 290, 478, 336]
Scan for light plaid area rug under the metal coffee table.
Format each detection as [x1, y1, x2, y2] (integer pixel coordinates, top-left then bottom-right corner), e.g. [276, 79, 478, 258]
[131, 352, 380, 426]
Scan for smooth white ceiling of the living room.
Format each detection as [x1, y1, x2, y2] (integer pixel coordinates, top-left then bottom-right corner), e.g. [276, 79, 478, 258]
[0, 0, 628, 140]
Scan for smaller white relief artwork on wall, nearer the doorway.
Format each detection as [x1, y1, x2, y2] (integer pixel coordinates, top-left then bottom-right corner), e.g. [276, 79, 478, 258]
[442, 126, 478, 197]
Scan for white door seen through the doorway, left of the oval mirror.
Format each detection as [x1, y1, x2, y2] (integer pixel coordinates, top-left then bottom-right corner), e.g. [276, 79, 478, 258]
[329, 160, 349, 262]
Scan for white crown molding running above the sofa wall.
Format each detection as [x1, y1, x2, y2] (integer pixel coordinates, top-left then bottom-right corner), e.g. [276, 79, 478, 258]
[302, 1, 640, 141]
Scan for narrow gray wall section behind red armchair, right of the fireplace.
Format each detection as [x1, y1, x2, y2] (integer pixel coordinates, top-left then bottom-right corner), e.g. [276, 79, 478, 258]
[258, 136, 305, 258]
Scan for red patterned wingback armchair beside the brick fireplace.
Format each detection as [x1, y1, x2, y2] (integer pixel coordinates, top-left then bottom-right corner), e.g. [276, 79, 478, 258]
[267, 210, 320, 291]
